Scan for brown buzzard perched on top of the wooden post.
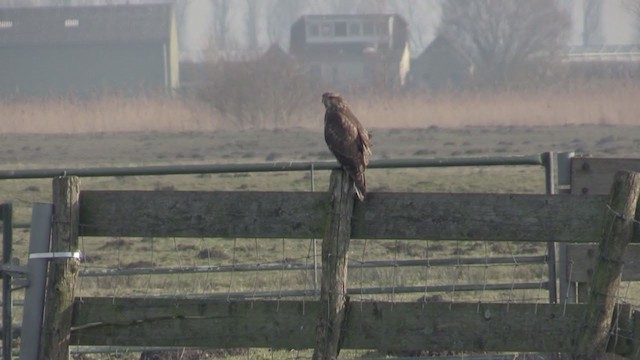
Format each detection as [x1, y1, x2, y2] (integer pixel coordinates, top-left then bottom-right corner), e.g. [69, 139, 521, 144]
[322, 92, 371, 201]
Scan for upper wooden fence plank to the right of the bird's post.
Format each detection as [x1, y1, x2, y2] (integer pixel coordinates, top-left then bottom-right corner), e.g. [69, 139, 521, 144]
[353, 193, 605, 242]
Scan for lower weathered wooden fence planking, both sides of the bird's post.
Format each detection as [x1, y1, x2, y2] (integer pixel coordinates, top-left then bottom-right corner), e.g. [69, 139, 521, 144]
[71, 297, 632, 355]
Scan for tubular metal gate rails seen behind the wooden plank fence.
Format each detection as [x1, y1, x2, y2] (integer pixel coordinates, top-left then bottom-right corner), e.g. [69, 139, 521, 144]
[0, 153, 554, 358]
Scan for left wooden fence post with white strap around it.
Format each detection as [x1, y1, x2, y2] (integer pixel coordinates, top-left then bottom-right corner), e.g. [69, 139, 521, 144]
[39, 176, 80, 360]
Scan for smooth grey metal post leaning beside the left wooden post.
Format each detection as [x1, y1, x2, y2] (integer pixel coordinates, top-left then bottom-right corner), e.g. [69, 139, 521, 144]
[20, 204, 53, 360]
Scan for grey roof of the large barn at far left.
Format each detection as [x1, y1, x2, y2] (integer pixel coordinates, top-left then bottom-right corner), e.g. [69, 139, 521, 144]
[0, 3, 173, 46]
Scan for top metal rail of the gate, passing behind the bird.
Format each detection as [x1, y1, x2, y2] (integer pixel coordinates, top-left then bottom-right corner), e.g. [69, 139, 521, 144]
[0, 154, 544, 179]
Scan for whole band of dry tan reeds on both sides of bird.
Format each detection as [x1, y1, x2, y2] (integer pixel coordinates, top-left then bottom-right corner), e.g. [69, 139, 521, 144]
[0, 80, 640, 134]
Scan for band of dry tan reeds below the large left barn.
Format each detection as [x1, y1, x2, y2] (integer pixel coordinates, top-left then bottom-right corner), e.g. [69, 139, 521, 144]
[0, 96, 216, 134]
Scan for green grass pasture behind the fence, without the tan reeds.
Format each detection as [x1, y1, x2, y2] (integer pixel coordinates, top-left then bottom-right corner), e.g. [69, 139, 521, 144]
[0, 125, 640, 359]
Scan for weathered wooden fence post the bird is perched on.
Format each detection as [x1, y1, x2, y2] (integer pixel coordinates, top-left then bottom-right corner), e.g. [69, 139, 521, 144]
[313, 169, 354, 360]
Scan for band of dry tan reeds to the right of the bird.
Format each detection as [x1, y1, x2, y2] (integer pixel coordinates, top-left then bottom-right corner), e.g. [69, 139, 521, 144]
[352, 82, 640, 128]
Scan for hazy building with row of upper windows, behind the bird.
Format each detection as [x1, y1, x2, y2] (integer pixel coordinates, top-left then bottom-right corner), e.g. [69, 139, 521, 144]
[289, 14, 410, 88]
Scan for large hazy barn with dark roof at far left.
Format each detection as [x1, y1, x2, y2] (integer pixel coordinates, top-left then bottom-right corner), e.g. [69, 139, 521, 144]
[0, 3, 179, 98]
